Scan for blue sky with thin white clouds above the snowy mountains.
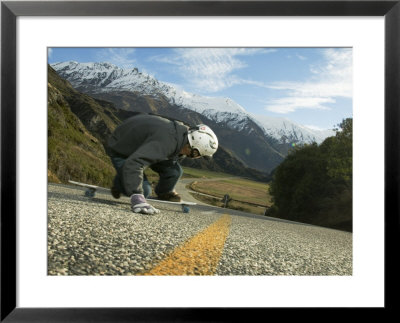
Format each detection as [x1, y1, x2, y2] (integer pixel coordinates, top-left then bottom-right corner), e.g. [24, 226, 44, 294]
[48, 47, 353, 129]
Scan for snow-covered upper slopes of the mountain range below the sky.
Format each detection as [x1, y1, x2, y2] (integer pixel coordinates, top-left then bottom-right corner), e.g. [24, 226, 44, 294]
[51, 61, 334, 144]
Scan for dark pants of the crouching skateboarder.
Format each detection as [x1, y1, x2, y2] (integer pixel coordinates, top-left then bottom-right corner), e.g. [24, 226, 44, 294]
[111, 157, 183, 197]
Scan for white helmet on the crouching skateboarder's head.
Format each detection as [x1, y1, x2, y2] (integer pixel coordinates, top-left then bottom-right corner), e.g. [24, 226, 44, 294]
[188, 124, 218, 157]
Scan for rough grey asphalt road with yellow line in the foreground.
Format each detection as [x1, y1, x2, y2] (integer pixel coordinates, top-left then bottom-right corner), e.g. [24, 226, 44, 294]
[48, 184, 352, 276]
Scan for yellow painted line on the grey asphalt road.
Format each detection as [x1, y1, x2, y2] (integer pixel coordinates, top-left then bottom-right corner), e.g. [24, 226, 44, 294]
[143, 214, 231, 276]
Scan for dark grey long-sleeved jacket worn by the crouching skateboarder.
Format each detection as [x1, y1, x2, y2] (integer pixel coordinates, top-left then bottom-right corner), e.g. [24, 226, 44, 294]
[107, 114, 188, 196]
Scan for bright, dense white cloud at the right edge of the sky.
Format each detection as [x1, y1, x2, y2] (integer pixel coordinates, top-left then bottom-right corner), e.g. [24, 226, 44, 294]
[265, 48, 353, 113]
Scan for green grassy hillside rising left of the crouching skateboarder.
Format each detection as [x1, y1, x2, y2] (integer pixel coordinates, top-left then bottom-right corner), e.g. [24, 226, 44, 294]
[48, 71, 114, 187]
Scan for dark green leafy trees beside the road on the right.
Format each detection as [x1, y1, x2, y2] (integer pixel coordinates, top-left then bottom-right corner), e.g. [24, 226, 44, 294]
[267, 119, 353, 230]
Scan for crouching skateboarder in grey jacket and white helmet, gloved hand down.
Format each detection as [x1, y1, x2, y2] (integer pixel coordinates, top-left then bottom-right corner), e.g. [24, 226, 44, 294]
[107, 114, 218, 214]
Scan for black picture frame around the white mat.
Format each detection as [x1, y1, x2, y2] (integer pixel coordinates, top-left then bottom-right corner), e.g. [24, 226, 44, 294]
[0, 0, 400, 322]
